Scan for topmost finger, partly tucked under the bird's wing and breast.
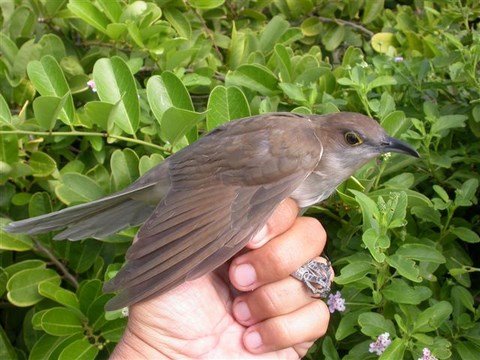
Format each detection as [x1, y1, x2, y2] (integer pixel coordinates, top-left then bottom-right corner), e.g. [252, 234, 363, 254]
[247, 198, 299, 249]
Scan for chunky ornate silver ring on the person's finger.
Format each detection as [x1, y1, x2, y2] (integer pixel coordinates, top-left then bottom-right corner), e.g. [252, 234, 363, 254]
[291, 258, 333, 299]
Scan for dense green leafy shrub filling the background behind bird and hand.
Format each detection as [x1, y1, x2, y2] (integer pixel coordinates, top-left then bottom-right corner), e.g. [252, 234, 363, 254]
[0, 0, 480, 359]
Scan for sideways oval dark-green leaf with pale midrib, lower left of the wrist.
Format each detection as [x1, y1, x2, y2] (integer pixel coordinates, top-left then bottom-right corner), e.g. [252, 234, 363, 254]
[40, 307, 83, 336]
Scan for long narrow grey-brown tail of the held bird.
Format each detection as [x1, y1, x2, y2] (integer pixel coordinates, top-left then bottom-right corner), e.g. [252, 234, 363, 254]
[4, 184, 155, 240]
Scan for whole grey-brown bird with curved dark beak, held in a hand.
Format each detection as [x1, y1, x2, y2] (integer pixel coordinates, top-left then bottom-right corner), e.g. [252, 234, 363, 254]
[5, 112, 420, 310]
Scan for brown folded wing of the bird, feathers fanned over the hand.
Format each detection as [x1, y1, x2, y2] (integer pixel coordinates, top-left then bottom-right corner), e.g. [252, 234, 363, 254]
[105, 114, 321, 309]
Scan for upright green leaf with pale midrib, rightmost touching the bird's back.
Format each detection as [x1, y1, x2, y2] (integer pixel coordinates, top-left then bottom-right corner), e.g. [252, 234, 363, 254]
[207, 85, 250, 130]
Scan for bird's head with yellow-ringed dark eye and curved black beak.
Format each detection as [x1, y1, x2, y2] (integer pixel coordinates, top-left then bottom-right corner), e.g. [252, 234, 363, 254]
[311, 112, 420, 181]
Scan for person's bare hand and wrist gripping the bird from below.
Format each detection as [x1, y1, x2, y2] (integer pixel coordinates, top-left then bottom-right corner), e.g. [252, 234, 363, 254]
[111, 199, 329, 359]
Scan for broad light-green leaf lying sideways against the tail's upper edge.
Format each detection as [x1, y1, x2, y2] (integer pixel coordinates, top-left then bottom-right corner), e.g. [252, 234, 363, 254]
[55, 173, 105, 205]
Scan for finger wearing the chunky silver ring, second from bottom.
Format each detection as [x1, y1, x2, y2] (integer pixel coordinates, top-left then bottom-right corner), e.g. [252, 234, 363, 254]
[233, 257, 333, 326]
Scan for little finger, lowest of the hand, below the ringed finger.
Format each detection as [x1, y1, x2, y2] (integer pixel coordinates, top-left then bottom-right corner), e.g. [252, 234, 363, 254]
[243, 301, 330, 354]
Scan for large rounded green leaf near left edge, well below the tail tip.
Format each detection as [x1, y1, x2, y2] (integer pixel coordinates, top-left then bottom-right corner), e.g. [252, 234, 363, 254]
[7, 268, 61, 307]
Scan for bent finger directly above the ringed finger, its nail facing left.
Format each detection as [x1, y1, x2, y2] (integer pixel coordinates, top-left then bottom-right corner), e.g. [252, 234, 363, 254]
[229, 217, 327, 291]
